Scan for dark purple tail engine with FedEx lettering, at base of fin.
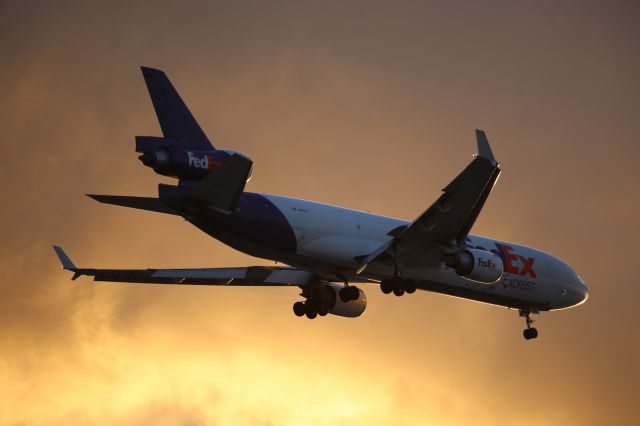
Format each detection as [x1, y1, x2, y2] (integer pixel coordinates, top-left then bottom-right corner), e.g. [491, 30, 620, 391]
[136, 136, 253, 182]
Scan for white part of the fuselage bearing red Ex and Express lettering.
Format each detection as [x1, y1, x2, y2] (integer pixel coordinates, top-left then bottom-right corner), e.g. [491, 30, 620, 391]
[263, 194, 587, 310]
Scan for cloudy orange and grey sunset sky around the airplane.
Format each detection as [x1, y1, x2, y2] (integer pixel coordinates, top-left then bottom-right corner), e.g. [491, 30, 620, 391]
[0, 1, 640, 425]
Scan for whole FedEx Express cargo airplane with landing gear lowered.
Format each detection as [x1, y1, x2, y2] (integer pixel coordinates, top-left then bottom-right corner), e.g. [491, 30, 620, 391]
[54, 67, 588, 340]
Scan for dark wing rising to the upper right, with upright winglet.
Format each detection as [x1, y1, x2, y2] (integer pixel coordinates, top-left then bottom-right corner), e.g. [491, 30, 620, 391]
[359, 130, 500, 272]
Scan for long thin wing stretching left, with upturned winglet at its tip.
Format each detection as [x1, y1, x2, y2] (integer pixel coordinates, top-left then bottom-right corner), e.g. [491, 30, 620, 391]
[53, 246, 313, 286]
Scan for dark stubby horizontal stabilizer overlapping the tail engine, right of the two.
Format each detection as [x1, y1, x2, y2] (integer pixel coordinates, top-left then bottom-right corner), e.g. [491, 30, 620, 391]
[186, 154, 253, 212]
